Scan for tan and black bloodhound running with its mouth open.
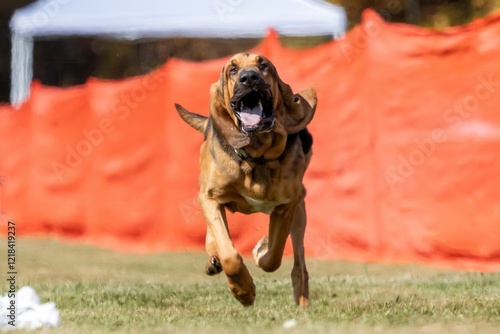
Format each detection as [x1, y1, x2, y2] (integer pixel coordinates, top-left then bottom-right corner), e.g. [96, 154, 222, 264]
[176, 53, 317, 307]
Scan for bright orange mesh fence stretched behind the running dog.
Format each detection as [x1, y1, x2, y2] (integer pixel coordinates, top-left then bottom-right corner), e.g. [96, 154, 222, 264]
[0, 11, 500, 270]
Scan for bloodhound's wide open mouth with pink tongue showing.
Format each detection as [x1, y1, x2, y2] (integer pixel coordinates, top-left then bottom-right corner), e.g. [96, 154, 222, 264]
[231, 90, 274, 132]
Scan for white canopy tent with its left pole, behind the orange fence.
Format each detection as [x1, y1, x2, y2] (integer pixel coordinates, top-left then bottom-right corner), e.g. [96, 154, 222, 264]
[10, 0, 347, 105]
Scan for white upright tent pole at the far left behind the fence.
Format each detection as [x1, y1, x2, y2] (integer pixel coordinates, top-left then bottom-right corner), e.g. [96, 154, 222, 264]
[10, 32, 33, 108]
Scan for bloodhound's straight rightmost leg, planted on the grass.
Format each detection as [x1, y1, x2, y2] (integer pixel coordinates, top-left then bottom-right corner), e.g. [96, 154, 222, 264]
[290, 201, 309, 307]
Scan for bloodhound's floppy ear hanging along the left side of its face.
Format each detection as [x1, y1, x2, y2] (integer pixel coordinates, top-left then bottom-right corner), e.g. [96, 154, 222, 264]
[210, 66, 250, 149]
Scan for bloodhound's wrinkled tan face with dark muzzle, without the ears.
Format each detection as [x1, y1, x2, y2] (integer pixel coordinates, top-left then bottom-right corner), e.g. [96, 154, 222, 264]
[222, 53, 277, 133]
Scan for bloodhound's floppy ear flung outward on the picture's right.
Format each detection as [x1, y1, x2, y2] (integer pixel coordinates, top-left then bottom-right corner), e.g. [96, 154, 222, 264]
[278, 73, 318, 134]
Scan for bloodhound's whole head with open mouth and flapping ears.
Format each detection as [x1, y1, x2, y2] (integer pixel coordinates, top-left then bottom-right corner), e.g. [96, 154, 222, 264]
[210, 53, 317, 148]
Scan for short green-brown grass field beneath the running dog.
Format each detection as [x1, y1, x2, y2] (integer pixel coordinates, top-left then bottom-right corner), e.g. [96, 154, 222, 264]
[4, 239, 500, 334]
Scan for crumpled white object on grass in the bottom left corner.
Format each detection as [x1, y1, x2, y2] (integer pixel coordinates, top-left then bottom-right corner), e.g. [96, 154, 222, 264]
[0, 286, 61, 331]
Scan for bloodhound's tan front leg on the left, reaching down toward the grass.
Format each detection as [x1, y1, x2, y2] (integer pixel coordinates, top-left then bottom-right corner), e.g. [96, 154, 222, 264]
[199, 194, 255, 306]
